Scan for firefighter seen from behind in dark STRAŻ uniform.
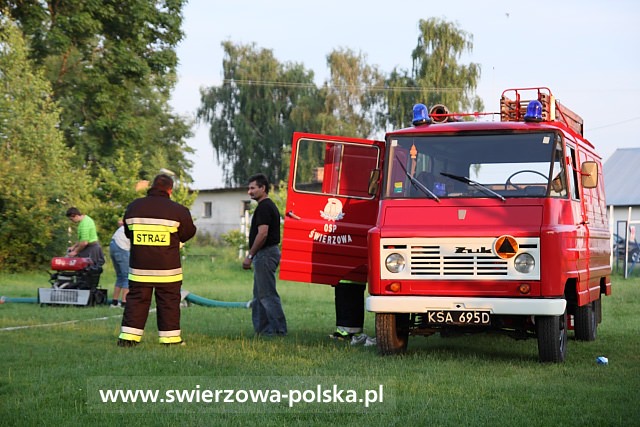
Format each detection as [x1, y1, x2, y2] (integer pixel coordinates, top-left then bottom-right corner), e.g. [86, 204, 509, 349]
[118, 174, 196, 347]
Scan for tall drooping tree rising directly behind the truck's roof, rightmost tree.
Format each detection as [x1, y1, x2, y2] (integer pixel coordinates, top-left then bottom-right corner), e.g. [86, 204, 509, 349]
[387, 18, 483, 127]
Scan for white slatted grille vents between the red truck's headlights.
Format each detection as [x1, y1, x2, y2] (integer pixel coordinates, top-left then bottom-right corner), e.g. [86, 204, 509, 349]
[410, 245, 508, 276]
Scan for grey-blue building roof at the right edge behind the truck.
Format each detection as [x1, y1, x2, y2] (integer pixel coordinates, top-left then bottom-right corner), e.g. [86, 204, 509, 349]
[603, 148, 640, 206]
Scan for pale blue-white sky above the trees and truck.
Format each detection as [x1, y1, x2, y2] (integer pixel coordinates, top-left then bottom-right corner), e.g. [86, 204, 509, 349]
[171, 0, 640, 190]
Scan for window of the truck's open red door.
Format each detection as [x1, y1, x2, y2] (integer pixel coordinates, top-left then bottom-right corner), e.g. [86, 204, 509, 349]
[294, 139, 380, 199]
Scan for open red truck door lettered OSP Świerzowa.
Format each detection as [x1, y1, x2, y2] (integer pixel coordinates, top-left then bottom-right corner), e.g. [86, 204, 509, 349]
[280, 133, 384, 285]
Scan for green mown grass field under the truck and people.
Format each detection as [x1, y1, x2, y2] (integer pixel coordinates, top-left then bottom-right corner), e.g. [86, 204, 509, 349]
[0, 248, 640, 426]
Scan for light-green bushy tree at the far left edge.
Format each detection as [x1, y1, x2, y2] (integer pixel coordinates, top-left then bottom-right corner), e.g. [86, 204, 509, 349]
[0, 15, 94, 271]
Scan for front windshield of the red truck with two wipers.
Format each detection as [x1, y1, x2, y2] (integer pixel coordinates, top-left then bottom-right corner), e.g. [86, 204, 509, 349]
[385, 132, 567, 200]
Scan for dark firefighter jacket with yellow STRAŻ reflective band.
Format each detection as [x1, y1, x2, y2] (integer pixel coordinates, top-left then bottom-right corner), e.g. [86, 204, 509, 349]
[124, 188, 196, 285]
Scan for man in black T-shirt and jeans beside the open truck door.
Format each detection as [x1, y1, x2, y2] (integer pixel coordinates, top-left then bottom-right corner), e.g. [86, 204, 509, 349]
[242, 174, 287, 336]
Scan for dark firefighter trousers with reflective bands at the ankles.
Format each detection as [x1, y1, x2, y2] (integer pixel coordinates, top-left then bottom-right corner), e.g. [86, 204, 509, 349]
[120, 281, 182, 344]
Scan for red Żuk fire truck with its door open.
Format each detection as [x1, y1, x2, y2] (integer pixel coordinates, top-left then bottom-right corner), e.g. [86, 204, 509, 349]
[280, 88, 611, 362]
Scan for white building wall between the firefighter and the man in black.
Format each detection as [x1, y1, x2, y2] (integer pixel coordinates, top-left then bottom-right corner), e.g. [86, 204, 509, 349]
[191, 188, 251, 238]
